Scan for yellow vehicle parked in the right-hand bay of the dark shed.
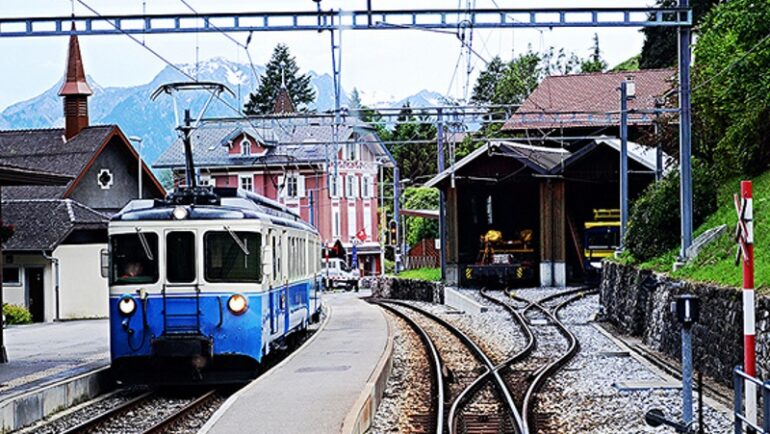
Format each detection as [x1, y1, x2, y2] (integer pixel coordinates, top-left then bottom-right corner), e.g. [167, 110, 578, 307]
[583, 209, 620, 271]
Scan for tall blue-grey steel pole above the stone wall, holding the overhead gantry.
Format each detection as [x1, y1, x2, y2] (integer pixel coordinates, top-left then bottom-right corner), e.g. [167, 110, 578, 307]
[679, 0, 692, 259]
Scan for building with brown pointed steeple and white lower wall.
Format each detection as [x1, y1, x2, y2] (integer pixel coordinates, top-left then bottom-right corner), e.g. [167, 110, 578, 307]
[0, 31, 165, 321]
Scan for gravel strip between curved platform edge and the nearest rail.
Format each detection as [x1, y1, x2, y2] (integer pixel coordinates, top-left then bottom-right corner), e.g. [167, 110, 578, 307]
[371, 311, 432, 434]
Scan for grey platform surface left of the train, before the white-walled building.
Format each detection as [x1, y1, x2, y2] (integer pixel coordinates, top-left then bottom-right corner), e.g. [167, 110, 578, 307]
[0, 319, 110, 401]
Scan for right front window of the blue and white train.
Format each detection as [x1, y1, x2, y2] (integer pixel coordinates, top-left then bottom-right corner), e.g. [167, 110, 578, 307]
[204, 230, 262, 283]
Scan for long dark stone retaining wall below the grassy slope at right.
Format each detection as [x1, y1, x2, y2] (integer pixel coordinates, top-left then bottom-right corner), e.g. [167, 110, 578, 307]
[599, 262, 770, 385]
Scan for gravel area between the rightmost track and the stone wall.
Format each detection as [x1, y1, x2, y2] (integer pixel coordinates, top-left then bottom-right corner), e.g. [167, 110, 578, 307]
[536, 295, 731, 434]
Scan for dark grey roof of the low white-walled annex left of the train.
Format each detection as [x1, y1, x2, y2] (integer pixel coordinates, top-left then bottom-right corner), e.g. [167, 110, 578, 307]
[2, 199, 109, 251]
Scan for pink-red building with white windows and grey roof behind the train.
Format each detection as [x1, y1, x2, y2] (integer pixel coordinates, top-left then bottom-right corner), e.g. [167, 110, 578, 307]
[153, 87, 391, 274]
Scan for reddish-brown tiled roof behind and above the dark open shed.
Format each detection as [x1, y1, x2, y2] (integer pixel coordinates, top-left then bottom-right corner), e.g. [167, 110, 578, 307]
[502, 69, 676, 132]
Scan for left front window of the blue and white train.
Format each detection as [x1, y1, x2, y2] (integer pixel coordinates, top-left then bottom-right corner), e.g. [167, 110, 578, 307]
[110, 232, 158, 285]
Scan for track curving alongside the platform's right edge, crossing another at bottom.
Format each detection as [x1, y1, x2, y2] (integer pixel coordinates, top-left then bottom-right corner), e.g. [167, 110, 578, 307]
[378, 300, 524, 434]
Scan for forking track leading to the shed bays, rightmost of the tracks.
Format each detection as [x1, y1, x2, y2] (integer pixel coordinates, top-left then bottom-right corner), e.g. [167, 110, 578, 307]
[480, 288, 595, 434]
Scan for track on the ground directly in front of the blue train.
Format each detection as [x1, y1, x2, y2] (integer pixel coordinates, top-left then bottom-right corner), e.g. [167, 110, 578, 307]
[62, 389, 220, 434]
